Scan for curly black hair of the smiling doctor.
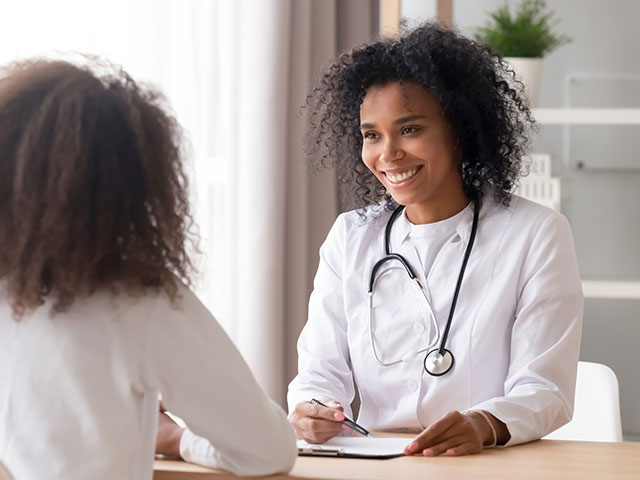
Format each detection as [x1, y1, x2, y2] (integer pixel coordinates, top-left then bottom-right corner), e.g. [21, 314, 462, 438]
[305, 22, 535, 212]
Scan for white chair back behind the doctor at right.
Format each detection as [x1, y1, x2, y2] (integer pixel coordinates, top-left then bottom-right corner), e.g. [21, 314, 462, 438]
[544, 362, 622, 442]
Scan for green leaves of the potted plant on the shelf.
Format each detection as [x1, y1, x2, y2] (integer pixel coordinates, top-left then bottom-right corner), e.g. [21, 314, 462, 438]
[475, 0, 571, 57]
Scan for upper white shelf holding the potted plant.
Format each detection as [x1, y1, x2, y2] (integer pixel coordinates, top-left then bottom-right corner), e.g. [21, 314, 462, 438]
[533, 108, 640, 125]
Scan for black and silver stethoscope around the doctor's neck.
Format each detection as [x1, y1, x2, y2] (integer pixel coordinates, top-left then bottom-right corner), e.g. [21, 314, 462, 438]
[368, 201, 480, 377]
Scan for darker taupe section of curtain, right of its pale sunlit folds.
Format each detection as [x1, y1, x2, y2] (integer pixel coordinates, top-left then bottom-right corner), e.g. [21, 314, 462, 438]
[284, 0, 379, 396]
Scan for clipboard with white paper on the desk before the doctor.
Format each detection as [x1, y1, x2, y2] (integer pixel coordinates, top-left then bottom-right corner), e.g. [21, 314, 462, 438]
[297, 437, 411, 458]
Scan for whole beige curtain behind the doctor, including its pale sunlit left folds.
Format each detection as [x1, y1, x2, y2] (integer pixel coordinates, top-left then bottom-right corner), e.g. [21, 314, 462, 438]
[229, 0, 378, 405]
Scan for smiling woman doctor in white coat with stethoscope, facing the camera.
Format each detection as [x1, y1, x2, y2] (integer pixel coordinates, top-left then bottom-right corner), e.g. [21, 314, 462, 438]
[288, 23, 583, 456]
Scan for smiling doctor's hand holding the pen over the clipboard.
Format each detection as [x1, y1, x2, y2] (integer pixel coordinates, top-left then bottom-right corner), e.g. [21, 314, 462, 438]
[291, 401, 349, 443]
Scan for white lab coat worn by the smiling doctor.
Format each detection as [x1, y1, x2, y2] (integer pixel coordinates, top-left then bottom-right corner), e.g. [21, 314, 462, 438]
[288, 194, 583, 445]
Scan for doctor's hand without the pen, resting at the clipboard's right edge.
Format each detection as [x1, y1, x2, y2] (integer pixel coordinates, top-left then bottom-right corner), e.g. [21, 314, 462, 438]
[404, 410, 510, 457]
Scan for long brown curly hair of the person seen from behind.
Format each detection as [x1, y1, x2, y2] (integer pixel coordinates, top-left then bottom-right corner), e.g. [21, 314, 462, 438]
[0, 57, 197, 319]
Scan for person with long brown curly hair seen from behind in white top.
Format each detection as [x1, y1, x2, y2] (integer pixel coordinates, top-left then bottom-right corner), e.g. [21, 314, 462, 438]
[0, 60, 297, 480]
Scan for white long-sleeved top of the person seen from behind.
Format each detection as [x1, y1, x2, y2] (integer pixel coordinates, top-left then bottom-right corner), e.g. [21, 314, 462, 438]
[0, 286, 296, 480]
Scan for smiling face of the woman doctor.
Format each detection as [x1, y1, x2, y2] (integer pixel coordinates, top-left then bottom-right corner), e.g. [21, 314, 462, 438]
[360, 82, 468, 224]
